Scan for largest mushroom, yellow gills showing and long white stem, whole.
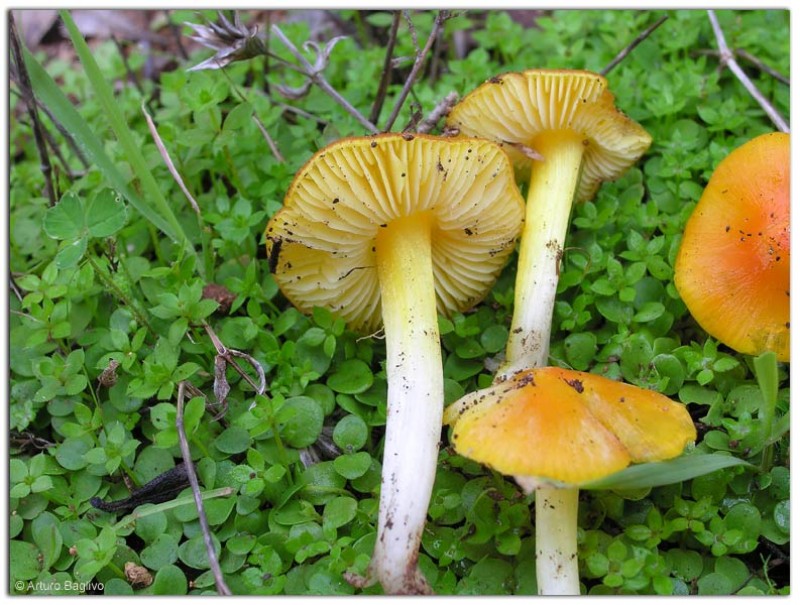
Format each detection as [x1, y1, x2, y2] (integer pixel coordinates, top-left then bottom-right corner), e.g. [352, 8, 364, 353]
[266, 134, 524, 593]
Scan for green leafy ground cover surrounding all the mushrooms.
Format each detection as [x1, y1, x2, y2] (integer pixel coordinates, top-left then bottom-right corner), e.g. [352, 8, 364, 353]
[8, 10, 790, 595]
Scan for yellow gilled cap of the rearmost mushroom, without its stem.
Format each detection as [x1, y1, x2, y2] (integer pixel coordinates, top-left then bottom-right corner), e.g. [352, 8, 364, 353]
[447, 69, 652, 201]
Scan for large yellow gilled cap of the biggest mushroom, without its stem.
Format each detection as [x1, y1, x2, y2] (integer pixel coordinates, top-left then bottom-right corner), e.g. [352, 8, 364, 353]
[266, 134, 524, 330]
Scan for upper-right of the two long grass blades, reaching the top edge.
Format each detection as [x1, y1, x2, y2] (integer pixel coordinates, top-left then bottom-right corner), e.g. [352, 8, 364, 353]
[59, 10, 195, 254]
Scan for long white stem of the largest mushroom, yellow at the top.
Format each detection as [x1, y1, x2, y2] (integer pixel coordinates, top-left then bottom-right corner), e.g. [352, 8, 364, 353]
[370, 214, 444, 594]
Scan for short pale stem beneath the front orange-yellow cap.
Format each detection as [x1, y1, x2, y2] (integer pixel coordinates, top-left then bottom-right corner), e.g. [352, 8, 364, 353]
[536, 487, 580, 595]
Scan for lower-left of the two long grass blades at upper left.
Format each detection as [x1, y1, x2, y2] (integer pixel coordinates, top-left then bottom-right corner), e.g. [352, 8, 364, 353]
[23, 50, 178, 241]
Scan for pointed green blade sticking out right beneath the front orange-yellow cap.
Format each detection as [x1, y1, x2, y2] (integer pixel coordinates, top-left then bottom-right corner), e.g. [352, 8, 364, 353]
[580, 454, 752, 490]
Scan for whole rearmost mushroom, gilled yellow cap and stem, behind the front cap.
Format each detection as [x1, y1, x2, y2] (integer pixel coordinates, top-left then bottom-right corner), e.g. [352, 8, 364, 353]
[447, 69, 651, 379]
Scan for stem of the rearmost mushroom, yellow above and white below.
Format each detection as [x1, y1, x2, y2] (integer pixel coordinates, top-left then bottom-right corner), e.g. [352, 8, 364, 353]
[504, 131, 584, 382]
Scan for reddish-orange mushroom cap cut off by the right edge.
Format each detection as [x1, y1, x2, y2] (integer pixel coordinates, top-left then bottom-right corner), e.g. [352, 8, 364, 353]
[675, 132, 790, 361]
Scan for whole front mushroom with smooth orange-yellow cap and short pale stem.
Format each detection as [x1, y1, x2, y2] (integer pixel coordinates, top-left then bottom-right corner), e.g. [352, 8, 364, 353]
[444, 367, 696, 595]
